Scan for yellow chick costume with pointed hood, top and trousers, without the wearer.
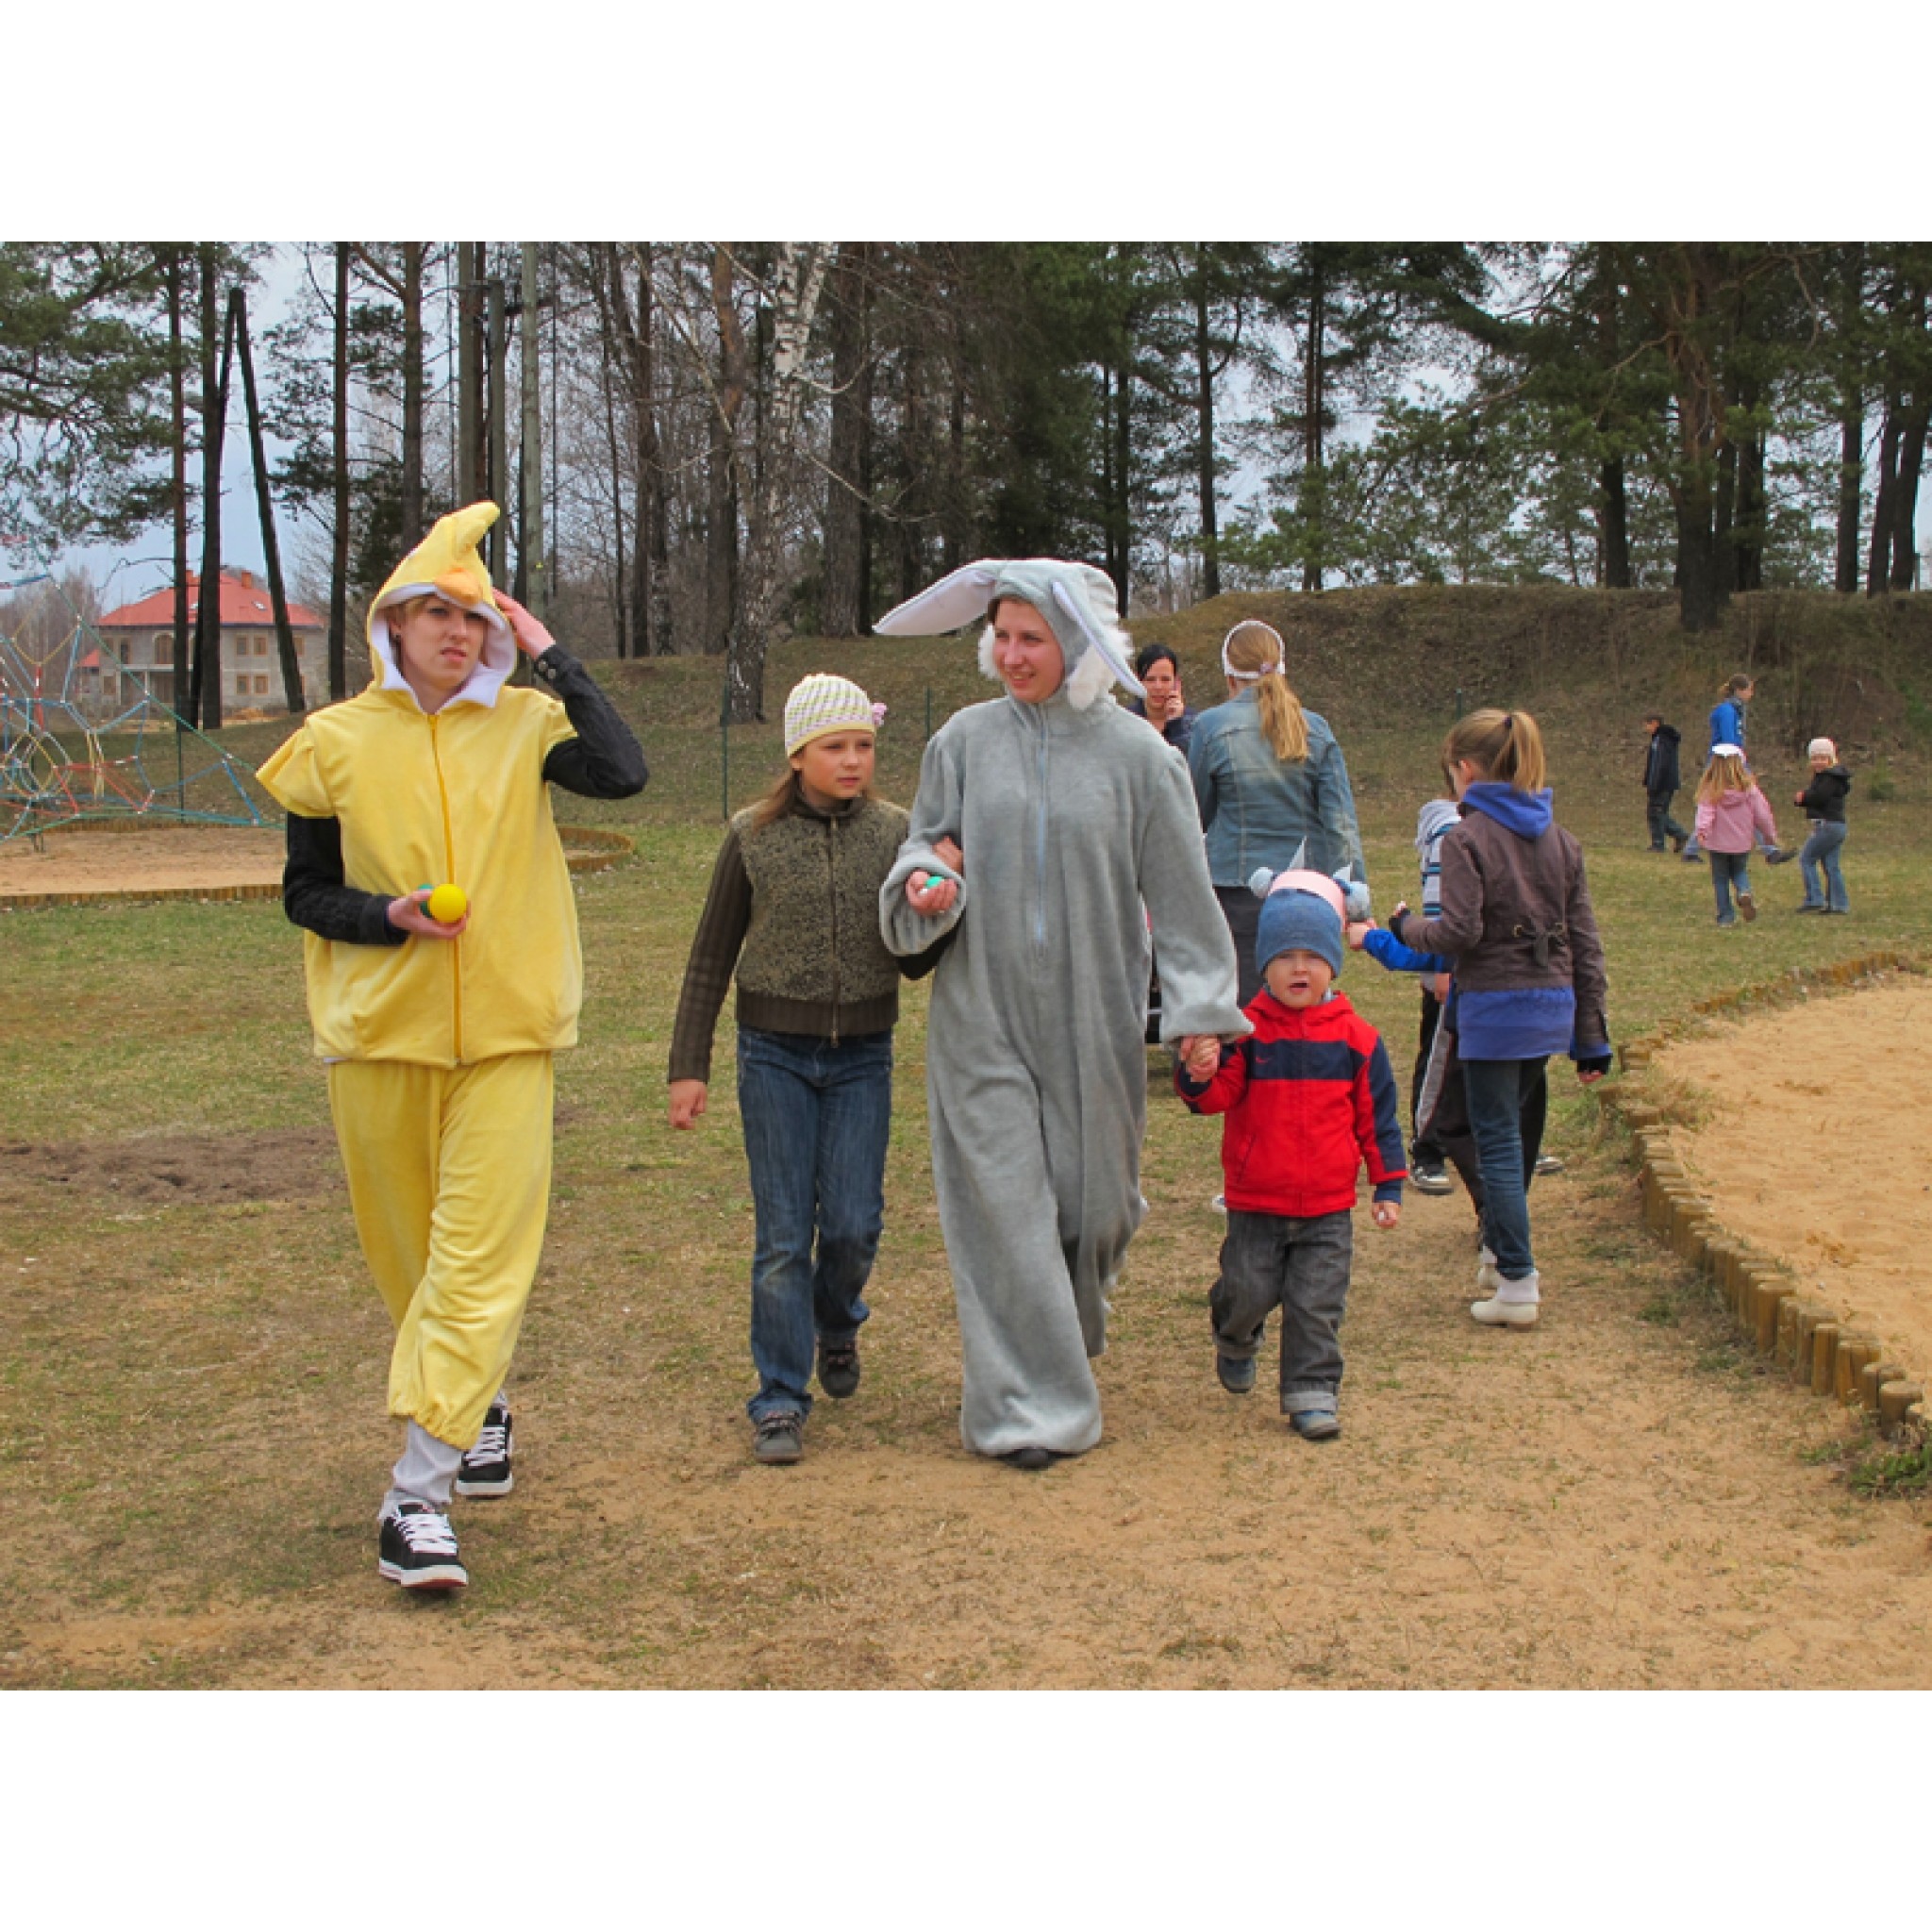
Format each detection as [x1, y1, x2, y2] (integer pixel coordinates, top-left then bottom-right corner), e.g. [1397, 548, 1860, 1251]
[257, 502, 583, 1449]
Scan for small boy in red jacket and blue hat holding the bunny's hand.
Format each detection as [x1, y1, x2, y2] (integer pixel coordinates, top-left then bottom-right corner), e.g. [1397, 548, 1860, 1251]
[1174, 872, 1408, 1441]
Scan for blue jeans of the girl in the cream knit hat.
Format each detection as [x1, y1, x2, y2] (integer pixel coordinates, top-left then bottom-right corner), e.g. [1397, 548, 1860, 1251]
[738, 1025, 892, 1422]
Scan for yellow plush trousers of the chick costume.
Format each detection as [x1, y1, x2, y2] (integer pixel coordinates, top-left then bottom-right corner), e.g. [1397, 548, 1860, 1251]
[328, 1053, 553, 1449]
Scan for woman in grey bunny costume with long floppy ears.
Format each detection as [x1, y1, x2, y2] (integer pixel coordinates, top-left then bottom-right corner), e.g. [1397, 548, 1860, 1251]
[874, 558, 1250, 1468]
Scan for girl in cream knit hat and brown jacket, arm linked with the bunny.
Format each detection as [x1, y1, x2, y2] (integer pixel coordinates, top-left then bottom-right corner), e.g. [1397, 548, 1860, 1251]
[671, 675, 957, 1462]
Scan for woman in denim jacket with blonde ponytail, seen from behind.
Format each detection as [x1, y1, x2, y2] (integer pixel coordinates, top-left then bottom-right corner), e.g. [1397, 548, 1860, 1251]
[1189, 620, 1368, 1007]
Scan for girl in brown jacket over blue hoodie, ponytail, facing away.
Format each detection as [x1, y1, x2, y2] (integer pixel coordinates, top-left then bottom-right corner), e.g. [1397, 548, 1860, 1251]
[1390, 711, 1609, 1327]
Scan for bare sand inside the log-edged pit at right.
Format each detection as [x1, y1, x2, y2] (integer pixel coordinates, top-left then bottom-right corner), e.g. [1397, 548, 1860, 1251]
[1654, 979, 1932, 1377]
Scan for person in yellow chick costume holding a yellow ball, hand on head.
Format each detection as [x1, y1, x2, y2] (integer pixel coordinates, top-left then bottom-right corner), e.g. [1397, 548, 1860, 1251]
[258, 502, 647, 1591]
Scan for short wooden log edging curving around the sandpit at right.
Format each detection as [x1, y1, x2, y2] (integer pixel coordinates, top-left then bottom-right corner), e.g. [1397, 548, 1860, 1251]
[1598, 949, 1932, 1441]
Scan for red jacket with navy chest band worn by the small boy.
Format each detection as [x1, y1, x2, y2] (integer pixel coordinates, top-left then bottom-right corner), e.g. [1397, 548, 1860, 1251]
[1174, 988, 1408, 1219]
